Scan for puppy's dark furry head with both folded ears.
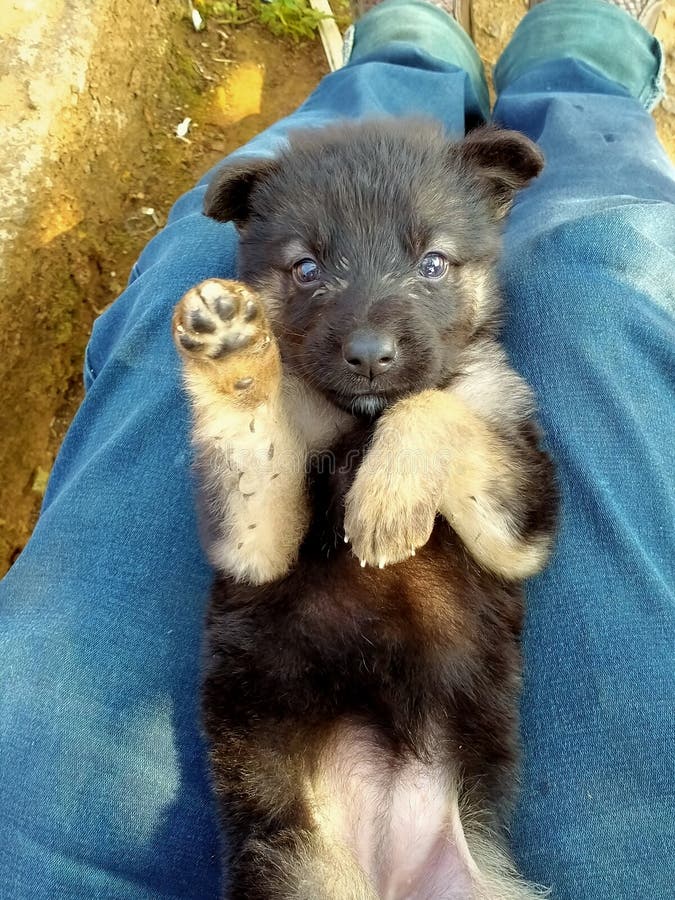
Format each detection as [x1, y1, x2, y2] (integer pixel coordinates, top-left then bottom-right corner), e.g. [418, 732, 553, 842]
[205, 120, 542, 416]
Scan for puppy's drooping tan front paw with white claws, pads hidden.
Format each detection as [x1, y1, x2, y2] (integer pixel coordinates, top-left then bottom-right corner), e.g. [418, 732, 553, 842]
[345, 451, 439, 568]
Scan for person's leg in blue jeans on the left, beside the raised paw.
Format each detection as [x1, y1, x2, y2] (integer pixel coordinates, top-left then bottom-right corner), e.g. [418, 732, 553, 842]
[0, 0, 486, 900]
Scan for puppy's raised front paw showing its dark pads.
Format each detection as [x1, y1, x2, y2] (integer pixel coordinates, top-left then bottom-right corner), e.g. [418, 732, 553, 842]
[173, 278, 281, 405]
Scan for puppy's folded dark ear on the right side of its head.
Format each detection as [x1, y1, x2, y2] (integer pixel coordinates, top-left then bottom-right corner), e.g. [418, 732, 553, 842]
[458, 125, 544, 218]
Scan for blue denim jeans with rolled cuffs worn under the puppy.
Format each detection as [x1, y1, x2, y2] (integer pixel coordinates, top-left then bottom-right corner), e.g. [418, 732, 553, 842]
[0, 0, 675, 900]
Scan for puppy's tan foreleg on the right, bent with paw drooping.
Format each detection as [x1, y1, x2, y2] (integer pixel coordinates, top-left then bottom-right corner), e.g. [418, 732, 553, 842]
[345, 387, 550, 579]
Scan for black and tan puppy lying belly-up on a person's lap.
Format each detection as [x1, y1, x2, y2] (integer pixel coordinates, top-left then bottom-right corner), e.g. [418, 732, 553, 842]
[174, 120, 556, 900]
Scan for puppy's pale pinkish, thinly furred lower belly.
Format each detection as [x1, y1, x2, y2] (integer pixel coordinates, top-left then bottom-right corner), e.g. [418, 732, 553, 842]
[311, 725, 477, 900]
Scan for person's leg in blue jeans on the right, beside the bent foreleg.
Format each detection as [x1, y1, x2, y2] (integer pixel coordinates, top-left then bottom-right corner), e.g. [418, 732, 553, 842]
[495, 0, 675, 900]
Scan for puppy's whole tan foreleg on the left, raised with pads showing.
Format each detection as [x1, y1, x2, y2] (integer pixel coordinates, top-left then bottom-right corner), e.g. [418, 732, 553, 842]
[173, 279, 308, 584]
